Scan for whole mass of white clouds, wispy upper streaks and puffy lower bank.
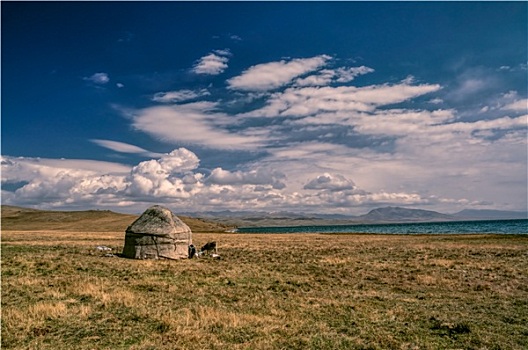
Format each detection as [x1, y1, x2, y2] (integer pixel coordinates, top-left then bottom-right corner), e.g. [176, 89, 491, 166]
[2, 50, 528, 214]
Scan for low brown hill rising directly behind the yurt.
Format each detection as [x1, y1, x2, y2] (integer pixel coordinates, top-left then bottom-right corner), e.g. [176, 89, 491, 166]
[1, 205, 232, 232]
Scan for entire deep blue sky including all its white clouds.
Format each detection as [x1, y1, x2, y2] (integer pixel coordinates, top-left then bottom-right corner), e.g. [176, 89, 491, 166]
[1, 1, 528, 215]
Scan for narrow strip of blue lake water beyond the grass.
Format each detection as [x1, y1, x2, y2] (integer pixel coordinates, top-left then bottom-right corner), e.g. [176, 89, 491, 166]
[237, 219, 528, 234]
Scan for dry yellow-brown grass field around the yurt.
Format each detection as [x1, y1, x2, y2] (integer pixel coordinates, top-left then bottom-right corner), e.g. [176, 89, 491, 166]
[2, 226, 528, 350]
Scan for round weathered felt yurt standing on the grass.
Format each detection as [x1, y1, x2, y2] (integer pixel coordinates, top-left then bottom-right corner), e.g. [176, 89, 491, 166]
[123, 205, 192, 259]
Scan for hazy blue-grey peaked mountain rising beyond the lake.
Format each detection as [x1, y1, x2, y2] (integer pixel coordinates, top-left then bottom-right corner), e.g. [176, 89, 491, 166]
[358, 207, 456, 222]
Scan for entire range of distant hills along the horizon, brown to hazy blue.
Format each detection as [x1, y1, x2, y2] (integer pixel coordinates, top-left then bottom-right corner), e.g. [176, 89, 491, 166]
[1, 205, 527, 232]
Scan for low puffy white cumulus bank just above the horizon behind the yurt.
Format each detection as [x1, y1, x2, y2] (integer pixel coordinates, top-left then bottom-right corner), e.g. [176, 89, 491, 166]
[2, 148, 458, 210]
